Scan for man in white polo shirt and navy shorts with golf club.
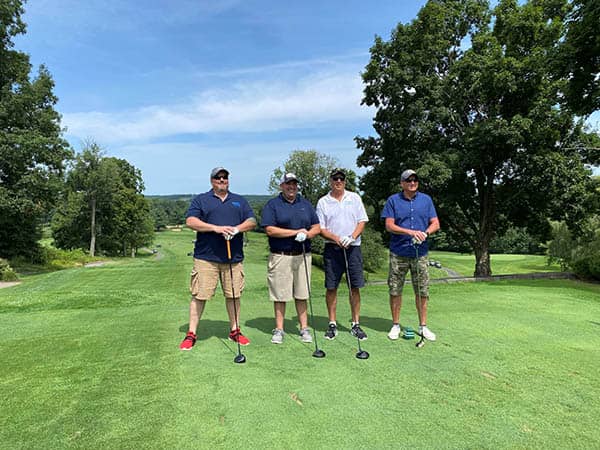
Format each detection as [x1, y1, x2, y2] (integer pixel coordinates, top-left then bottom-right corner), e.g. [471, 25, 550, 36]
[317, 169, 369, 341]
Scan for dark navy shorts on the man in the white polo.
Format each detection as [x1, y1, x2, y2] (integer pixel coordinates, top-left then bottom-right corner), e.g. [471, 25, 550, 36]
[323, 244, 365, 289]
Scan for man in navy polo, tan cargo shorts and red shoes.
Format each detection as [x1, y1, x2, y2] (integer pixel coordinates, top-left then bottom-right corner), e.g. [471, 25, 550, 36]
[179, 167, 256, 350]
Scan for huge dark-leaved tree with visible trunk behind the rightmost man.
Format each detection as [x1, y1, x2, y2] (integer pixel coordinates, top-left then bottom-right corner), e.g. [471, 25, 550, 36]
[357, 0, 590, 276]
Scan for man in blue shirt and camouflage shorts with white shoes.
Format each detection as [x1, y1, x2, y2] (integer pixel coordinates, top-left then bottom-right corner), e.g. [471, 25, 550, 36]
[381, 169, 440, 341]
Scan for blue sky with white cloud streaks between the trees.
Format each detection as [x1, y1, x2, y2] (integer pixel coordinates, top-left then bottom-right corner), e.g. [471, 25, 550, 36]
[16, 0, 425, 194]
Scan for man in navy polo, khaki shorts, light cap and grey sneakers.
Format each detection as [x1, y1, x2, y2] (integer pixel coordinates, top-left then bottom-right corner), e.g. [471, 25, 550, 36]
[261, 173, 321, 344]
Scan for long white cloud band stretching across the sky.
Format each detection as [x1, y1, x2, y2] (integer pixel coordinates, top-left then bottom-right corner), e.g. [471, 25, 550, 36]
[63, 72, 373, 144]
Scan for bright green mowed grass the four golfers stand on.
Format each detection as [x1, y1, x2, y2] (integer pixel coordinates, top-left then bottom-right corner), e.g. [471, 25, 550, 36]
[0, 231, 600, 449]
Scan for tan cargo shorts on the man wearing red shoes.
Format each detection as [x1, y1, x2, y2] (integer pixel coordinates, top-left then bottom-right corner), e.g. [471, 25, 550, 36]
[190, 258, 244, 300]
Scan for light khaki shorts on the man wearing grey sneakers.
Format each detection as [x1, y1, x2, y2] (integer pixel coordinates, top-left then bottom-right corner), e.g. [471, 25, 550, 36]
[267, 253, 312, 302]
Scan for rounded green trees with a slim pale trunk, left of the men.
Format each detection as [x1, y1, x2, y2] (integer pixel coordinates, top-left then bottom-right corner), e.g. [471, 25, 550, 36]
[52, 141, 154, 256]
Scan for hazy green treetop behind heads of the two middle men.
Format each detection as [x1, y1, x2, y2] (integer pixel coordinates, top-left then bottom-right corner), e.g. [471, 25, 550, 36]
[269, 150, 356, 205]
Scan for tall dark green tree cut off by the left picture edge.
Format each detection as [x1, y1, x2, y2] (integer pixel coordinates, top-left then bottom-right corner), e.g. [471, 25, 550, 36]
[0, 0, 71, 257]
